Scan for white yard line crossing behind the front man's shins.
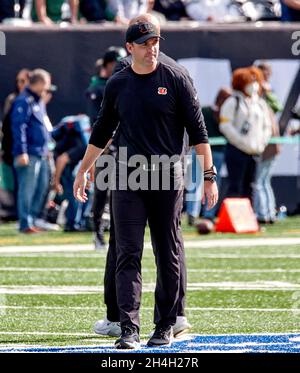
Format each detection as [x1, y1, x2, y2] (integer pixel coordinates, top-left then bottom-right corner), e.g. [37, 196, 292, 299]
[0, 281, 300, 295]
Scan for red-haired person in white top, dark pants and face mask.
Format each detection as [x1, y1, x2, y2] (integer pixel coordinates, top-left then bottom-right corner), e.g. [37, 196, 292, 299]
[220, 68, 272, 201]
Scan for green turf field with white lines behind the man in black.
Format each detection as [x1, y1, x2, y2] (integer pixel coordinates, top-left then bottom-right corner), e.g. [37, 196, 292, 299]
[0, 217, 300, 346]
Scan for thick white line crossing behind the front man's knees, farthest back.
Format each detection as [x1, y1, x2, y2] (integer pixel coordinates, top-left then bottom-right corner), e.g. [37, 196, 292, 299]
[0, 237, 300, 254]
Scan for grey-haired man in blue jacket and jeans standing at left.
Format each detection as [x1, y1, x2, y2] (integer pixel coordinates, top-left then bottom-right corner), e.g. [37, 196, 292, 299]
[11, 69, 51, 233]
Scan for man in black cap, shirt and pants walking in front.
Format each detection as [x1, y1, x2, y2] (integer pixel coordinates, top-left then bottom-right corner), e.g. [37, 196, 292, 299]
[74, 13, 218, 349]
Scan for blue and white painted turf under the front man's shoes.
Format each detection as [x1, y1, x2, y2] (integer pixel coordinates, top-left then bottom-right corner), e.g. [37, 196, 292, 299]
[0, 334, 300, 353]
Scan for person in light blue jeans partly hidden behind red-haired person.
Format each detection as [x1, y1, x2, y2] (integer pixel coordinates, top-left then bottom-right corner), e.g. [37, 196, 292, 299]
[252, 62, 282, 224]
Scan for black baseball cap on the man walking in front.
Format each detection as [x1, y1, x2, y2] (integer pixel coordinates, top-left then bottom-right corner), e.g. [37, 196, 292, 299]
[126, 22, 163, 44]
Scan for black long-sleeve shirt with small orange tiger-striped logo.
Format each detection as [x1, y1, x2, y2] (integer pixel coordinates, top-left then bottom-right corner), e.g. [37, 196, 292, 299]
[90, 63, 208, 159]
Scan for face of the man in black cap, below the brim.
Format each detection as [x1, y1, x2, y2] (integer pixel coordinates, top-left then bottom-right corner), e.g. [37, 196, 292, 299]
[127, 38, 159, 67]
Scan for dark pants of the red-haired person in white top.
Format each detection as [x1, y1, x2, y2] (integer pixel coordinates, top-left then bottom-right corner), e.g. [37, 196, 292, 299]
[225, 144, 256, 201]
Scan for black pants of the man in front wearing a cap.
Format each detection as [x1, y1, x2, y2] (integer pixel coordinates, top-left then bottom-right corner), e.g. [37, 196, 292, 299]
[105, 167, 185, 329]
